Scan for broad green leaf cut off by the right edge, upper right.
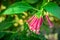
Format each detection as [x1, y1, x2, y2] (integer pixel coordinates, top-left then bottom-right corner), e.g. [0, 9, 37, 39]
[44, 2, 60, 19]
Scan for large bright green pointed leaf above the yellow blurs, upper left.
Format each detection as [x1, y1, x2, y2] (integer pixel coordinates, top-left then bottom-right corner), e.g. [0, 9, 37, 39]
[3, 2, 32, 14]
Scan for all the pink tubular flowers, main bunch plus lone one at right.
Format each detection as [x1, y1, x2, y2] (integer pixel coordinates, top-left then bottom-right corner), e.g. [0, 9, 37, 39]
[27, 15, 54, 34]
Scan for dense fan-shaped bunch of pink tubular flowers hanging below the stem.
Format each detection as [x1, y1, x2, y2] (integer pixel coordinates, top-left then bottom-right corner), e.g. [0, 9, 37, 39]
[27, 16, 43, 34]
